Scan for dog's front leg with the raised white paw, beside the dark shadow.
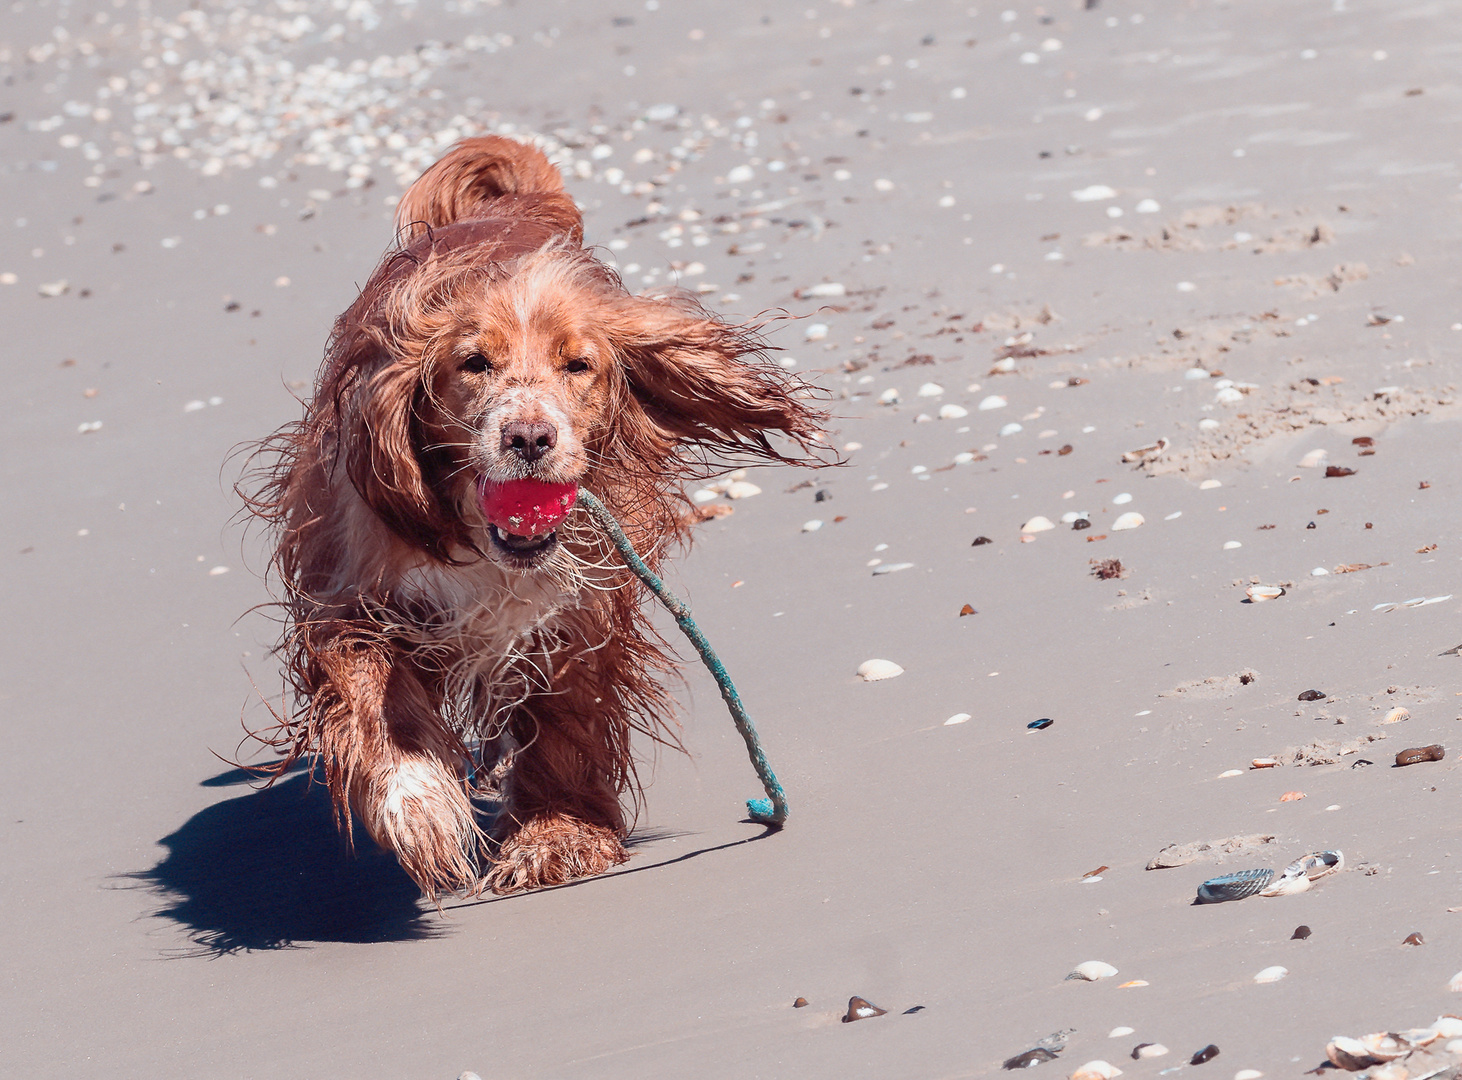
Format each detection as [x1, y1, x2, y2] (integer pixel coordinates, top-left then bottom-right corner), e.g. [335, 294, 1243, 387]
[307, 630, 481, 897]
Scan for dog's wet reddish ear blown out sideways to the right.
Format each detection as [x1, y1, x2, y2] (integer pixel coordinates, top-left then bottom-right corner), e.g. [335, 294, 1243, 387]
[616, 297, 827, 463]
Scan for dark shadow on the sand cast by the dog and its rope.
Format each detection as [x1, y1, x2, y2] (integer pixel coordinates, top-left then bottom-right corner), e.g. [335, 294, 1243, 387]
[137, 767, 775, 957]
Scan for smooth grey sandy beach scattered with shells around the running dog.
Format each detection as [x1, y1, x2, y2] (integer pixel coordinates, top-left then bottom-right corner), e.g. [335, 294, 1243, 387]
[0, 0, 1462, 1080]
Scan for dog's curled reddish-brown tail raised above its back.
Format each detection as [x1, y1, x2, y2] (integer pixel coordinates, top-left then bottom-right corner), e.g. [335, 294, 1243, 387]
[396, 134, 583, 243]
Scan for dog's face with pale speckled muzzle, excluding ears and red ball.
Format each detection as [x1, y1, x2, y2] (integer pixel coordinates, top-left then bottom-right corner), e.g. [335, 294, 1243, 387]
[421, 275, 618, 570]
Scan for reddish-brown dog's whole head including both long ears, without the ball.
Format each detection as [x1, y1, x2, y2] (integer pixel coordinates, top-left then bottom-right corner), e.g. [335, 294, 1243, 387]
[320, 235, 822, 571]
